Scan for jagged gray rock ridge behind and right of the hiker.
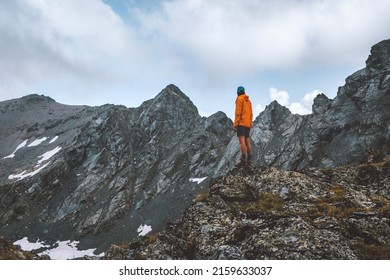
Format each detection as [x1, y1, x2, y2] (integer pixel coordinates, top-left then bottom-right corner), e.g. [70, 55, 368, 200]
[216, 40, 390, 175]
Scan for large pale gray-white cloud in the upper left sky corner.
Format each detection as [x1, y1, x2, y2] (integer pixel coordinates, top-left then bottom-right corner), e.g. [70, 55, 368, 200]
[0, 0, 148, 101]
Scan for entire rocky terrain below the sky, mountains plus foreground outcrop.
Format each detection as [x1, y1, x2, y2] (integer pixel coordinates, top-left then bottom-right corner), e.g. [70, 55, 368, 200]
[0, 40, 390, 259]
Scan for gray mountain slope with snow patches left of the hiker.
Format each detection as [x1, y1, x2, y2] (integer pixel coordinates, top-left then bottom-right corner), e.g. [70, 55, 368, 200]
[0, 85, 232, 252]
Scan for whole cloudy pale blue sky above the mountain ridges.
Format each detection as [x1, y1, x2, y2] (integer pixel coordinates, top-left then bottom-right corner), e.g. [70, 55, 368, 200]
[0, 0, 390, 117]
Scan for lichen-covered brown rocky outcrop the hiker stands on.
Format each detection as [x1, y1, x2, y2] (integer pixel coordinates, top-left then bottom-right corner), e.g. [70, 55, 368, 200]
[105, 158, 390, 260]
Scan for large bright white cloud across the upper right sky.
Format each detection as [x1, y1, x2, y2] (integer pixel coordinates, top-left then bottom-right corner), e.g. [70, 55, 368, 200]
[132, 0, 390, 75]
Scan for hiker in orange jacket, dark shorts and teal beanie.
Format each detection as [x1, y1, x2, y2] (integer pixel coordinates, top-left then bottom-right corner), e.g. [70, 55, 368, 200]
[234, 86, 253, 166]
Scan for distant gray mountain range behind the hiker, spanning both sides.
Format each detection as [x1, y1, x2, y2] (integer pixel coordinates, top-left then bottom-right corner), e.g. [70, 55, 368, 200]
[0, 40, 390, 254]
